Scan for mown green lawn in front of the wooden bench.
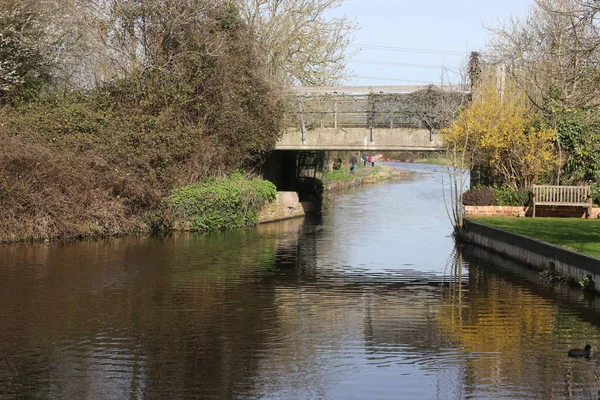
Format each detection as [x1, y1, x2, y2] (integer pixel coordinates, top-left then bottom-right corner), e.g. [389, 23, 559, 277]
[472, 217, 600, 258]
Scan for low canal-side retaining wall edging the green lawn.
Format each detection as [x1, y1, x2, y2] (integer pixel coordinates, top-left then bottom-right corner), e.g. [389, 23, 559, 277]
[459, 219, 600, 292]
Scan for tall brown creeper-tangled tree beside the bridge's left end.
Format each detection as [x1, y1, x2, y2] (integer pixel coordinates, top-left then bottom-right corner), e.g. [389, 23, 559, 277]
[86, 0, 282, 165]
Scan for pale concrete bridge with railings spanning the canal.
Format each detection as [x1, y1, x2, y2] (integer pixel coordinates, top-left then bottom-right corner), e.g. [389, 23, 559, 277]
[275, 86, 466, 151]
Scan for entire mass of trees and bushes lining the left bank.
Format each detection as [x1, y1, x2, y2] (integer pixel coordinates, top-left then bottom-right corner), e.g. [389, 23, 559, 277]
[0, 0, 353, 242]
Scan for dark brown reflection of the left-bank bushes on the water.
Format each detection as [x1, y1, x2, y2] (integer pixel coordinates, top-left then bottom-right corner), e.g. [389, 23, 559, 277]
[0, 227, 290, 398]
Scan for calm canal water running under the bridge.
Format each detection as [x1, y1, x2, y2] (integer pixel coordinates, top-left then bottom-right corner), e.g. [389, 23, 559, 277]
[0, 164, 600, 399]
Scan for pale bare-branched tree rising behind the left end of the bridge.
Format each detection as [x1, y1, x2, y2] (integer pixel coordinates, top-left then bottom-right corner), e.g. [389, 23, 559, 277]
[239, 0, 357, 86]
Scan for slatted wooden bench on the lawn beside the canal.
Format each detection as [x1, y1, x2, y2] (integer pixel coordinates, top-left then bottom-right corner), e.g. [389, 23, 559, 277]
[532, 185, 592, 218]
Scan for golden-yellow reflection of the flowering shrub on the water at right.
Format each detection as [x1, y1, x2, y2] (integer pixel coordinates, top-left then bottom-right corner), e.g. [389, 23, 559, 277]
[438, 245, 598, 398]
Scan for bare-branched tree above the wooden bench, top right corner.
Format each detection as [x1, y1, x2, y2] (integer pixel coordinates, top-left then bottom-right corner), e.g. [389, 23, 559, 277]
[488, 0, 600, 112]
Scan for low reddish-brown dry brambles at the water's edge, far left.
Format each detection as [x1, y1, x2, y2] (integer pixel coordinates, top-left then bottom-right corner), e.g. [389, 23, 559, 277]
[0, 132, 145, 242]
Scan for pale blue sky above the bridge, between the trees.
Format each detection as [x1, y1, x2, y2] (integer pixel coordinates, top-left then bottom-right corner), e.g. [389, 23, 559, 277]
[333, 0, 533, 86]
